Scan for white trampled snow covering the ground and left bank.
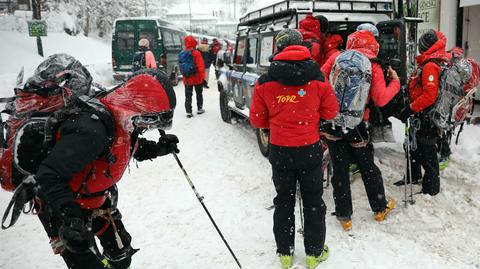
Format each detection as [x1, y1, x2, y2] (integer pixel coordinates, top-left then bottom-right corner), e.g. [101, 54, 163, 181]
[0, 29, 480, 269]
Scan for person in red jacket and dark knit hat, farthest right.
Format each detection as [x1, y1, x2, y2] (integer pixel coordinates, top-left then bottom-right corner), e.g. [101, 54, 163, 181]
[396, 29, 449, 195]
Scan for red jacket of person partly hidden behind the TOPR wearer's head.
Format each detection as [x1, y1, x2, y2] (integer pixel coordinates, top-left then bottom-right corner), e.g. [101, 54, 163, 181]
[298, 14, 324, 64]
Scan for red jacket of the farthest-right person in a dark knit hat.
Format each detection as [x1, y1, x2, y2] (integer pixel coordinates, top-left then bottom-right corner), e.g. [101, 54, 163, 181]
[408, 31, 448, 113]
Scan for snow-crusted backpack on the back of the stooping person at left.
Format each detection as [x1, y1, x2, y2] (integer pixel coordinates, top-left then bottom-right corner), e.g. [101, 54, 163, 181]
[0, 54, 114, 191]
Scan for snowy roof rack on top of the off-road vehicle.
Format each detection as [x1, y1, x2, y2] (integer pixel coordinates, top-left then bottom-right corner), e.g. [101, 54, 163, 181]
[239, 0, 393, 26]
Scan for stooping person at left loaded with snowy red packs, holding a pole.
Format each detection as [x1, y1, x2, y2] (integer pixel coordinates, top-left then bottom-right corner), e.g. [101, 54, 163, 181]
[1, 54, 178, 269]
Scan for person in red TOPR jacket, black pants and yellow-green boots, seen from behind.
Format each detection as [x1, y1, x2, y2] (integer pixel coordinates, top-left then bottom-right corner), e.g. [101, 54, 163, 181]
[250, 29, 338, 269]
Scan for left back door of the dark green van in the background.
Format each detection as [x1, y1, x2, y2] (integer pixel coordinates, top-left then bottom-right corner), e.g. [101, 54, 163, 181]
[112, 21, 136, 72]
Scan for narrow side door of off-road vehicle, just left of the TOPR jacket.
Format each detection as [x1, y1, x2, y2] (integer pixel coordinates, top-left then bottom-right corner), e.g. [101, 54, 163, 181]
[241, 34, 261, 108]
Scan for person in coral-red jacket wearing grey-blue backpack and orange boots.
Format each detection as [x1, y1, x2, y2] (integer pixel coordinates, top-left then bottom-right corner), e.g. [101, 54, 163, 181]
[322, 25, 400, 230]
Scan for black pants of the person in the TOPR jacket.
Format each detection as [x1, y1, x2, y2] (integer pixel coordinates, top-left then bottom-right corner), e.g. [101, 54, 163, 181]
[269, 142, 326, 256]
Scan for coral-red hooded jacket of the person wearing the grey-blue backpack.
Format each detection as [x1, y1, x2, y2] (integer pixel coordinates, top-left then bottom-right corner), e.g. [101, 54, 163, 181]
[321, 30, 400, 121]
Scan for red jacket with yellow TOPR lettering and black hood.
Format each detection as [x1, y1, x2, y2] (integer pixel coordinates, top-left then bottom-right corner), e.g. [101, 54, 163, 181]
[250, 46, 338, 147]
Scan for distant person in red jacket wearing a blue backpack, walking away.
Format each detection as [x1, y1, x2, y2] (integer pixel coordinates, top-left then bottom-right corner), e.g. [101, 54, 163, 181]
[183, 35, 205, 118]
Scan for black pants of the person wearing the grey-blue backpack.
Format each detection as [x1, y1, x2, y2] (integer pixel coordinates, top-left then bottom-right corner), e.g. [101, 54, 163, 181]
[328, 140, 387, 220]
